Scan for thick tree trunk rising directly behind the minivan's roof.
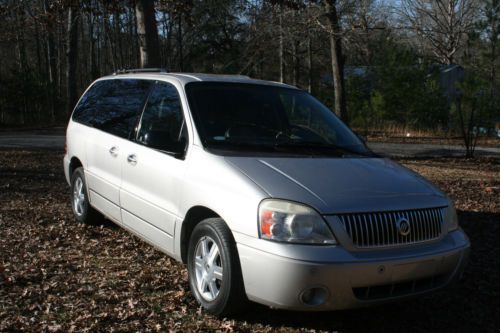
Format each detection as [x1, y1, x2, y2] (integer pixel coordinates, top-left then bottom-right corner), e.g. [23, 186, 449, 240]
[135, 0, 160, 68]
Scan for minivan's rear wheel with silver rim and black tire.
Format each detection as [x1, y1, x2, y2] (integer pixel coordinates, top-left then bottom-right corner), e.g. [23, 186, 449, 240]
[71, 167, 103, 224]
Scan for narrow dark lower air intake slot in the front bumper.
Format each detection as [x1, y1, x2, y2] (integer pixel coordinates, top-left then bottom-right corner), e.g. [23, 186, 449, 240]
[352, 274, 448, 301]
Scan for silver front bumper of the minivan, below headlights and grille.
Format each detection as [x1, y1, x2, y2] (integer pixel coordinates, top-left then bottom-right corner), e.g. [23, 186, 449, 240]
[236, 230, 470, 311]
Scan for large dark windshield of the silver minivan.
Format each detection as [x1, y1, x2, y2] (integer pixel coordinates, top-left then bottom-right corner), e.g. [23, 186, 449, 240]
[186, 82, 372, 156]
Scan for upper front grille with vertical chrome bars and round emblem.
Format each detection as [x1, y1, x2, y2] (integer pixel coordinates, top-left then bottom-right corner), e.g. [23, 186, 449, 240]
[338, 208, 445, 248]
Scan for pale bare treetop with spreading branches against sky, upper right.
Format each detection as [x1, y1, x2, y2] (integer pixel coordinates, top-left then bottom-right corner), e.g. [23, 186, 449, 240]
[401, 0, 477, 65]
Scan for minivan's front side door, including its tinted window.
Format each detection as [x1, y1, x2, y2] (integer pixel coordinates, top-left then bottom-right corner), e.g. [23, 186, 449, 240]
[120, 82, 187, 253]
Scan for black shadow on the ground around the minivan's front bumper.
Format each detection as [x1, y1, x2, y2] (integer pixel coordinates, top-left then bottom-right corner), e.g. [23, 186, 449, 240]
[234, 211, 500, 332]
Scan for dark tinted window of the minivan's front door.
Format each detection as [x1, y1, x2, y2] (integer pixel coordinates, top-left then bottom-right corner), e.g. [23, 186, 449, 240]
[137, 82, 185, 152]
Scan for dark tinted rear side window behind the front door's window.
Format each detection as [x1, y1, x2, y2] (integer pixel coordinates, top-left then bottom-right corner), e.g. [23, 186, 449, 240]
[73, 79, 154, 138]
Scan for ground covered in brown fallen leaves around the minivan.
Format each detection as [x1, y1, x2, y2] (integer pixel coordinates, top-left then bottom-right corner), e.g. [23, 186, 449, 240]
[0, 150, 500, 332]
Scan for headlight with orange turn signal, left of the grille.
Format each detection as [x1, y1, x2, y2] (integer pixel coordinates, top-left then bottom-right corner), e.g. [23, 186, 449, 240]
[259, 199, 337, 244]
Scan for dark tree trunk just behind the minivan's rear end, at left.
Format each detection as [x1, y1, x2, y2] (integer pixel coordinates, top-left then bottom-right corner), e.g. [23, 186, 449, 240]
[66, 1, 80, 115]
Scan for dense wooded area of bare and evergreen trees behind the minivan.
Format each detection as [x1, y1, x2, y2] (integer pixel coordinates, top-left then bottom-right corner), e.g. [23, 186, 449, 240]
[0, 0, 500, 143]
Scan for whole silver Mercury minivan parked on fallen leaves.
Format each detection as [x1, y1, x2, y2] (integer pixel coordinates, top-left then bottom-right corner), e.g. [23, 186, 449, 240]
[64, 70, 470, 315]
